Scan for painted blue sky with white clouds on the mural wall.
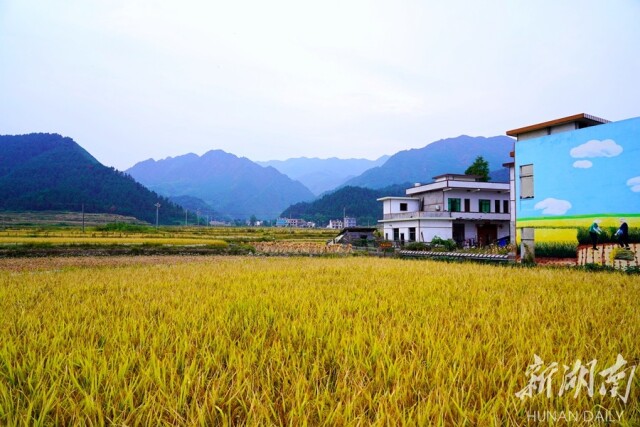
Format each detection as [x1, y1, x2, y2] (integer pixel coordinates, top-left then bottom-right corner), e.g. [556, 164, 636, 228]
[516, 117, 640, 219]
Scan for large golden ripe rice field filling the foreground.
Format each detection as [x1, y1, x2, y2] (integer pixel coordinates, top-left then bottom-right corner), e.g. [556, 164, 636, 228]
[0, 257, 640, 426]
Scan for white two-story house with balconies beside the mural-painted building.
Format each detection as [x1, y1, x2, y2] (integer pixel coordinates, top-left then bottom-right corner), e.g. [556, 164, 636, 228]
[378, 174, 510, 246]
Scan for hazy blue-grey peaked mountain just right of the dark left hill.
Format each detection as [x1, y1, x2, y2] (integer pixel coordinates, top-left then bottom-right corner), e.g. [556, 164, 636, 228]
[127, 150, 315, 219]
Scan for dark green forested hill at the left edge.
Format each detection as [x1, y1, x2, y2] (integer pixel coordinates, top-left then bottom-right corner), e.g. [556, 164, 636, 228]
[0, 133, 184, 224]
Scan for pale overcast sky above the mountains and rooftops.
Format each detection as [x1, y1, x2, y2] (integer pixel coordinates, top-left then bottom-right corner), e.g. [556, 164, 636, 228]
[0, 0, 640, 169]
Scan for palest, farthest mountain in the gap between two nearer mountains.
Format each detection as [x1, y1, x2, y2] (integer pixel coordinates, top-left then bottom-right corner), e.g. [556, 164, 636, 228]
[256, 156, 389, 195]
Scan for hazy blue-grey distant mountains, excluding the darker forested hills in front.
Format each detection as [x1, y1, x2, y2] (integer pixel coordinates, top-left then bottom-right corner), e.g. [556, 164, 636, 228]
[127, 135, 513, 219]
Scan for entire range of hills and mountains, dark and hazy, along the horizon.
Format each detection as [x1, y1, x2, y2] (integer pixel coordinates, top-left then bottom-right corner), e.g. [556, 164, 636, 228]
[0, 134, 513, 223]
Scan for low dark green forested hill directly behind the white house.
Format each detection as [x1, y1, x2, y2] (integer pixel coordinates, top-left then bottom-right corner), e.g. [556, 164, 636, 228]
[281, 183, 411, 226]
